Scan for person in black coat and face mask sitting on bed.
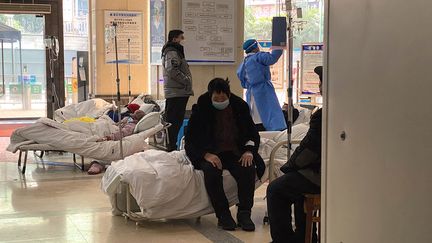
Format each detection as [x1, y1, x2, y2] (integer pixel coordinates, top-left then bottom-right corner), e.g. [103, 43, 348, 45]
[185, 78, 265, 231]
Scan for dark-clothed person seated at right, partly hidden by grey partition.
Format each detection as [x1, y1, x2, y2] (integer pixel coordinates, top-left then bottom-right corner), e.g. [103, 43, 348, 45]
[267, 66, 322, 243]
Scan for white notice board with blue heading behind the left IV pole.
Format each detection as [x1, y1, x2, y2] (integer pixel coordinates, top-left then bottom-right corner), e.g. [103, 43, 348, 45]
[104, 10, 143, 64]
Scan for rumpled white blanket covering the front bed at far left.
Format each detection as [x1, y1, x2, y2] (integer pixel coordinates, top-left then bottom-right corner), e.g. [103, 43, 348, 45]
[7, 118, 163, 161]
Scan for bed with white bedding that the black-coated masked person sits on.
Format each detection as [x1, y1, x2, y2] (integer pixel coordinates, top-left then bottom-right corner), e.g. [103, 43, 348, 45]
[101, 124, 308, 224]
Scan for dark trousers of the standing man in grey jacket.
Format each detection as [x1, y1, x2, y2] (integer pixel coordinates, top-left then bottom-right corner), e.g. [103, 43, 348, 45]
[165, 97, 189, 151]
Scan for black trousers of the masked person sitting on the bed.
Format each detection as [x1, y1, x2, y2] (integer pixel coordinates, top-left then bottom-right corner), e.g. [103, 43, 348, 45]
[200, 152, 256, 218]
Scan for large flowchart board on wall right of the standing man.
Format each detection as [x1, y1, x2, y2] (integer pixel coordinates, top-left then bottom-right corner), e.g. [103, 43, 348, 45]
[182, 0, 236, 65]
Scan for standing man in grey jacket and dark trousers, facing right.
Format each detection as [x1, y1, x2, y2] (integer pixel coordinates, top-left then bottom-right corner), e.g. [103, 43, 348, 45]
[162, 30, 193, 151]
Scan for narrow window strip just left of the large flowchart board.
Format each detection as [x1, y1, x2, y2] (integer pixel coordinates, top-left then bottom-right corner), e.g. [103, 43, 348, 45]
[150, 0, 165, 65]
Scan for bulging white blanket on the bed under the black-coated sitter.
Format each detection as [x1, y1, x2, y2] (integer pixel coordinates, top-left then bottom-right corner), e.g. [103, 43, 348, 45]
[101, 126, 307, 219]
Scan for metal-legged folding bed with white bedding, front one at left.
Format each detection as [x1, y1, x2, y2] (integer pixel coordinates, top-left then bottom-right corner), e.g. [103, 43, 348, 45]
[7, 112, 164, 174]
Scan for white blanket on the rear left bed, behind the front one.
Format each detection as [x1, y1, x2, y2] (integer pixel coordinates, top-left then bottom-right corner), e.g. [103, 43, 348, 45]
[54, 98, 114, 122]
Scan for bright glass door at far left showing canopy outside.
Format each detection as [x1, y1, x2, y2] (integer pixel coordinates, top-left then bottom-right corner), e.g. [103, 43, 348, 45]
[0, 13, 47, 119]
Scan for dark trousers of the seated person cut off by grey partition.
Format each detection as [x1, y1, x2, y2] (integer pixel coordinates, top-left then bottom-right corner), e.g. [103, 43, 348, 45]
[267, 172, 320, 243]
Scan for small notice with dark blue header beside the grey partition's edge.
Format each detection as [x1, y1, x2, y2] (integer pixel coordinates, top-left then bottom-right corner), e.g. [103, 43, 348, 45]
[300, 44, 324, 95]
